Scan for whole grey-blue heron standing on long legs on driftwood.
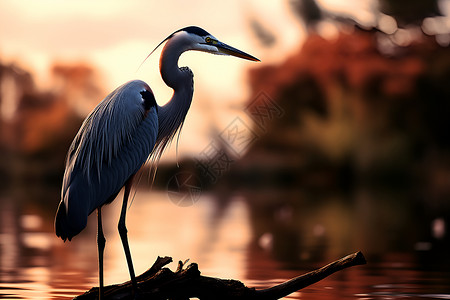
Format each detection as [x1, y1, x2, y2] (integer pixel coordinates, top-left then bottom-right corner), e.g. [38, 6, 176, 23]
[55, 26, 259, 298]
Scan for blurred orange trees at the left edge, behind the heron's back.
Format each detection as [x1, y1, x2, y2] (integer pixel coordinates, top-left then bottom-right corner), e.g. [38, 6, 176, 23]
[0, 61, 103, 186]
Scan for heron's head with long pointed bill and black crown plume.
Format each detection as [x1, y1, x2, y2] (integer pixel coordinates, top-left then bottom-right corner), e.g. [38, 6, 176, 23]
[149, 26, 259, 61]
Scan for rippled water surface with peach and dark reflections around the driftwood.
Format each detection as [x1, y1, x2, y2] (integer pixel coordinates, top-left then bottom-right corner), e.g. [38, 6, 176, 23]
[0, 189, 450, 299]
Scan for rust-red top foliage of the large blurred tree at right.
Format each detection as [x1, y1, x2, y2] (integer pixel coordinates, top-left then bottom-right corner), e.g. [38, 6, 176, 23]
[250, 31, 425, 102]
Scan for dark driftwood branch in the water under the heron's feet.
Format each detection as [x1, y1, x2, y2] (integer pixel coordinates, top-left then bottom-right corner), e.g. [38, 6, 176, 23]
[75, 252, 366, 300]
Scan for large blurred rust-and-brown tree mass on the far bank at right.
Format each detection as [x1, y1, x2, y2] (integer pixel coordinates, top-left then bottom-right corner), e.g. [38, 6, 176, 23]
[245, 30, 449, 189]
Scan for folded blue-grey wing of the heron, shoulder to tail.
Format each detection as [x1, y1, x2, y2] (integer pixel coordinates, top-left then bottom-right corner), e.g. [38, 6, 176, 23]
[56, 81, 158, 239]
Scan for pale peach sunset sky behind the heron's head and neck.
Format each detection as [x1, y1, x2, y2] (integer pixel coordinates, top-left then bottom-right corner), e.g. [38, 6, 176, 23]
[0, 0, 404, 159]
